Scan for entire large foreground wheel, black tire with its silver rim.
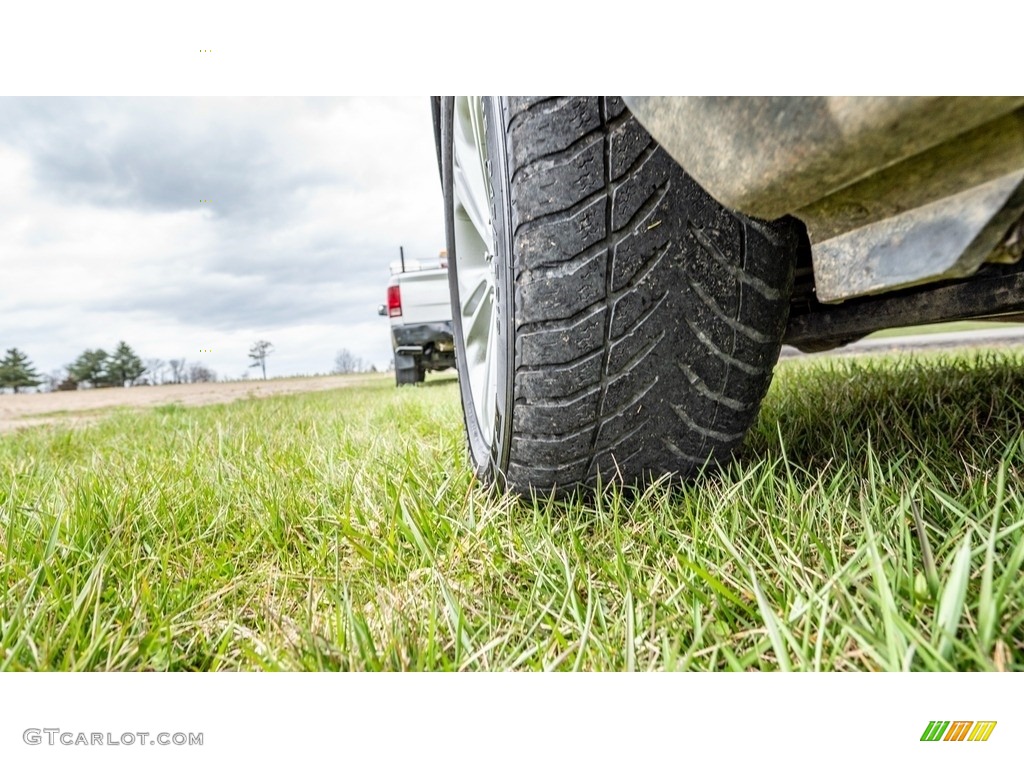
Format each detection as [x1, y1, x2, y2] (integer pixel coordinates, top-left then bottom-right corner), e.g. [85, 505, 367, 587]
[439, 97, 809, 494]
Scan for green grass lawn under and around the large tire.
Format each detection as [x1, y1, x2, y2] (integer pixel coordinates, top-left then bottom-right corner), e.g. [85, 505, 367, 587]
[0, 352, 1024, 670]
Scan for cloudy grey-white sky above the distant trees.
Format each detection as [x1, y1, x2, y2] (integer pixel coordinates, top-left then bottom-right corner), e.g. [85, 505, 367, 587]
[0, 97, 444, 378]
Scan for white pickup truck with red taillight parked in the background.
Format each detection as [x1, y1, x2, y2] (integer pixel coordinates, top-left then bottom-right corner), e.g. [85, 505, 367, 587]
[378, 251, 455, 387]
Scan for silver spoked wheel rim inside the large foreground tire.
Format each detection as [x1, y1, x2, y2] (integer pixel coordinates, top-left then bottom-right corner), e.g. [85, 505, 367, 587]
[452, 96, 498, 449]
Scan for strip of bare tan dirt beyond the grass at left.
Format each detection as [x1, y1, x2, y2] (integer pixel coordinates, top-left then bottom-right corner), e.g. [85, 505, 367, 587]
[0, 374, 387, 432]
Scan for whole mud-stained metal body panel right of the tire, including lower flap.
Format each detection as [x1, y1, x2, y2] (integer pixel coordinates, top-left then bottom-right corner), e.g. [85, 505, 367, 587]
[627, 96, 1024, 302]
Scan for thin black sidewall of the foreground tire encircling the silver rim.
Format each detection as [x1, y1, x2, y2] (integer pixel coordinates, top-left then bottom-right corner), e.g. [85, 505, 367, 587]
[440, 96, 515, 482]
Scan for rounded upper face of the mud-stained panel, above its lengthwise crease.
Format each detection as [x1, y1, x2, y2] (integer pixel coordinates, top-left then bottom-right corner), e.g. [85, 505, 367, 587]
[625, 96, 1024, 219]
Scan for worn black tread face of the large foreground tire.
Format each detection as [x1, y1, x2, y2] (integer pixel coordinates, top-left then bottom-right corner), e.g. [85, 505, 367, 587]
[503, 97, 806, 493]
